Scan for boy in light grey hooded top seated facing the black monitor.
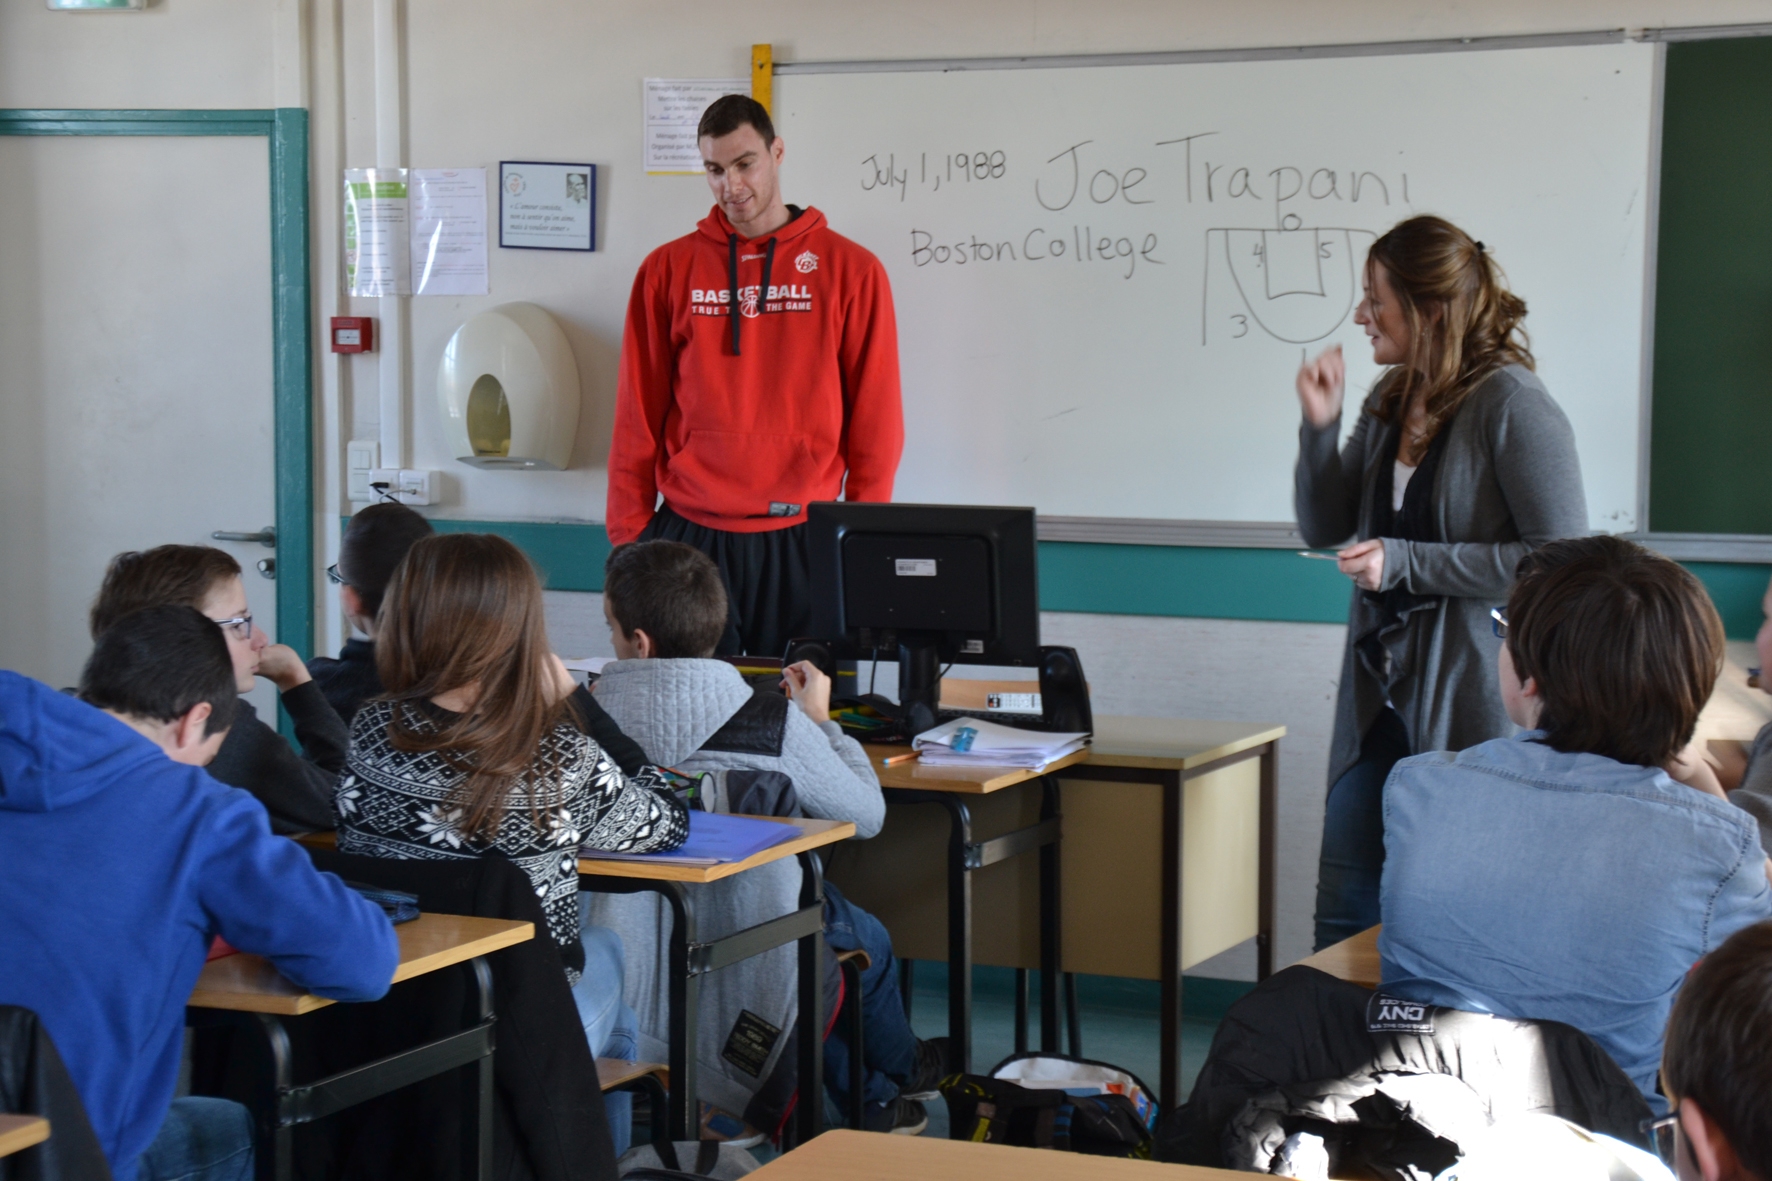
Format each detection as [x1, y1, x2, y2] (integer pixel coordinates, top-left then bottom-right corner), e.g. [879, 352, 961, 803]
[588, 541, 948, 1135]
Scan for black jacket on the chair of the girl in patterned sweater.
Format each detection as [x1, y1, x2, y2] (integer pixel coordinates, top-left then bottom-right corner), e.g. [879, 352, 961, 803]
[193, 849, 617, 1181]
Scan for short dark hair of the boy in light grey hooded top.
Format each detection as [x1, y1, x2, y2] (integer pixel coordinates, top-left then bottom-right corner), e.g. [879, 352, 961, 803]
[602, 541, 727, 660]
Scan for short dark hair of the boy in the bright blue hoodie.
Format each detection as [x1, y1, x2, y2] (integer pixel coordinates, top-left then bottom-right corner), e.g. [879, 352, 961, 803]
[80, 605, 239, 738]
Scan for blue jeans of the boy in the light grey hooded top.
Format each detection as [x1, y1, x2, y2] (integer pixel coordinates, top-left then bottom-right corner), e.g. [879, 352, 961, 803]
[824, 881, 916, 1110]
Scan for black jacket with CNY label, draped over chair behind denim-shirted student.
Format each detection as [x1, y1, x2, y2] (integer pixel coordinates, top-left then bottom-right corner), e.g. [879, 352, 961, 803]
[1157, 966, 1650, 1177]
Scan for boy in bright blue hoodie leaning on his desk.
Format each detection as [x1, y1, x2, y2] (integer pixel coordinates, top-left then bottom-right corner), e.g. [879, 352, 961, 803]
[0, 606, 399, 1181]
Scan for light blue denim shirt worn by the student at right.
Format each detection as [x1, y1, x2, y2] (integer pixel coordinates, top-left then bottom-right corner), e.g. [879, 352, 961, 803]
[1379, 731, 1772, 1112]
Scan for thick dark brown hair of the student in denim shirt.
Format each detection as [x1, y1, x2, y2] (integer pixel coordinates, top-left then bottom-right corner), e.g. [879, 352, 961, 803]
[1508, 537, 1722, 766]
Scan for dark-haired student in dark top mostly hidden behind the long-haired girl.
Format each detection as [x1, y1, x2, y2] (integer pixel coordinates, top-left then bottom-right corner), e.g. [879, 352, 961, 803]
[308, 504, 432, 725]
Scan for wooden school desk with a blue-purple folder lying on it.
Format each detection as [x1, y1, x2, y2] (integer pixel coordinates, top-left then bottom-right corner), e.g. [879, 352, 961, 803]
[578, 816, 856, 1144]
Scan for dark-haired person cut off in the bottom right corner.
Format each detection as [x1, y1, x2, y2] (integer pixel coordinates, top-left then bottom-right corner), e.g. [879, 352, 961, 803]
[1655, 922, 1772, 1181]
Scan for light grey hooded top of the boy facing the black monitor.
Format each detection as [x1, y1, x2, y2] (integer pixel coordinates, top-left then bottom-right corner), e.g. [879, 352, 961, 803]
[587, 660, 886, 1114]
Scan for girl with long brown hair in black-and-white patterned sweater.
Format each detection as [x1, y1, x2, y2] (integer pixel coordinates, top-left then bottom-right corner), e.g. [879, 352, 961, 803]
[337, 534, 689, 1151]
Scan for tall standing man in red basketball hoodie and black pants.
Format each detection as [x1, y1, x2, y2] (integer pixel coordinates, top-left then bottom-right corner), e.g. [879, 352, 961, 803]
[608, 94, 904, 656]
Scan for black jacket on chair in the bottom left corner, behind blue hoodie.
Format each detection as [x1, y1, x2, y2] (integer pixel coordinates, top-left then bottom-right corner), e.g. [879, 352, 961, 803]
[0, 1005, 110, 1181]
